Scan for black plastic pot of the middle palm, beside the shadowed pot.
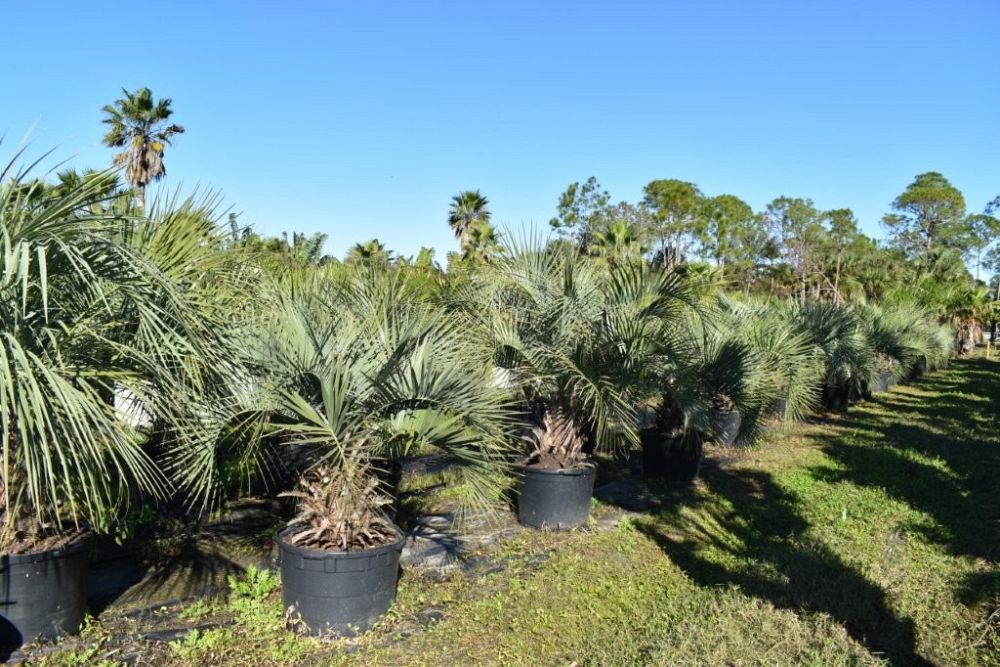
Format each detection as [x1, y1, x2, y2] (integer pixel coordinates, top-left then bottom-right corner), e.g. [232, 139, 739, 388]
[517, 466, 596, 530]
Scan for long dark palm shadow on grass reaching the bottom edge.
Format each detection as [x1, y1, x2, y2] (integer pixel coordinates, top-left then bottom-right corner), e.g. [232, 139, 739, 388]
[638, 469, 930, 665]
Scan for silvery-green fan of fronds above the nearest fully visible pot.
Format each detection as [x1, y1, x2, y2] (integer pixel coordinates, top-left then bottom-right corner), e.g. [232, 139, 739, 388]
[259, 273, 508, 552]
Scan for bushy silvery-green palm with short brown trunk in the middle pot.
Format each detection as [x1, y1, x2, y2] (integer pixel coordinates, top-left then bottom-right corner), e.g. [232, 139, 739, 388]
[475, 240, 694, 468]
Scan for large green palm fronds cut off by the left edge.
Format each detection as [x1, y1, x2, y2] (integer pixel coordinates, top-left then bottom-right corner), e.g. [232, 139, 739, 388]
[0, 158, 215, 549]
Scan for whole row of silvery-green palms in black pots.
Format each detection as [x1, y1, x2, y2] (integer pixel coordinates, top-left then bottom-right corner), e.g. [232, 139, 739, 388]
[0, 160, 947, 647]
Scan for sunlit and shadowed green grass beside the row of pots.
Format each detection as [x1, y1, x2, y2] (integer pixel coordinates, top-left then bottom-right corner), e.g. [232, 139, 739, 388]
[33, 358, 1000, 665]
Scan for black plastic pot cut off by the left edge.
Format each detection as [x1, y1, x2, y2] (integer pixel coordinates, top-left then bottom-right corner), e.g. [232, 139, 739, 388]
[0, 537, 90, 659]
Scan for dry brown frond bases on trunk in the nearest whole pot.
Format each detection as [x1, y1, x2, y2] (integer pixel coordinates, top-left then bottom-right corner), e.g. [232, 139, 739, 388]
[281, 460, 399, 551]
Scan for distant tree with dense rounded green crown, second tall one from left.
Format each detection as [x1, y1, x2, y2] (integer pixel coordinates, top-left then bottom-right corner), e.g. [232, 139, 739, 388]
[643, 179, 705, 265]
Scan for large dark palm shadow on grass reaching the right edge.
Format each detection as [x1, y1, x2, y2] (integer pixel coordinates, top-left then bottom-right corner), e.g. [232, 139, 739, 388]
[813, 358, 1000, 604]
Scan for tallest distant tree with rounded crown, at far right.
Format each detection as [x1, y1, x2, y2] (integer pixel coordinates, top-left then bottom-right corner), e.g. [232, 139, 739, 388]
[882, 171, 968, 268]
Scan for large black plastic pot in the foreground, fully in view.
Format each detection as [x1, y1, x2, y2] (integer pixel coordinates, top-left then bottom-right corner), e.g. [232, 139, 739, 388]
[277, 526, 405, 636]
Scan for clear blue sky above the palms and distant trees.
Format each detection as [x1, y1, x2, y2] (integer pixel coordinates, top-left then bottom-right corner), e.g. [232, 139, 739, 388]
[0, 0, 1000, 257]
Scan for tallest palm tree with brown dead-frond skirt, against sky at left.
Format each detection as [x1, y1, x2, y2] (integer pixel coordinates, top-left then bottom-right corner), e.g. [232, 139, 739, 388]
[101, 88, 184, 208]
